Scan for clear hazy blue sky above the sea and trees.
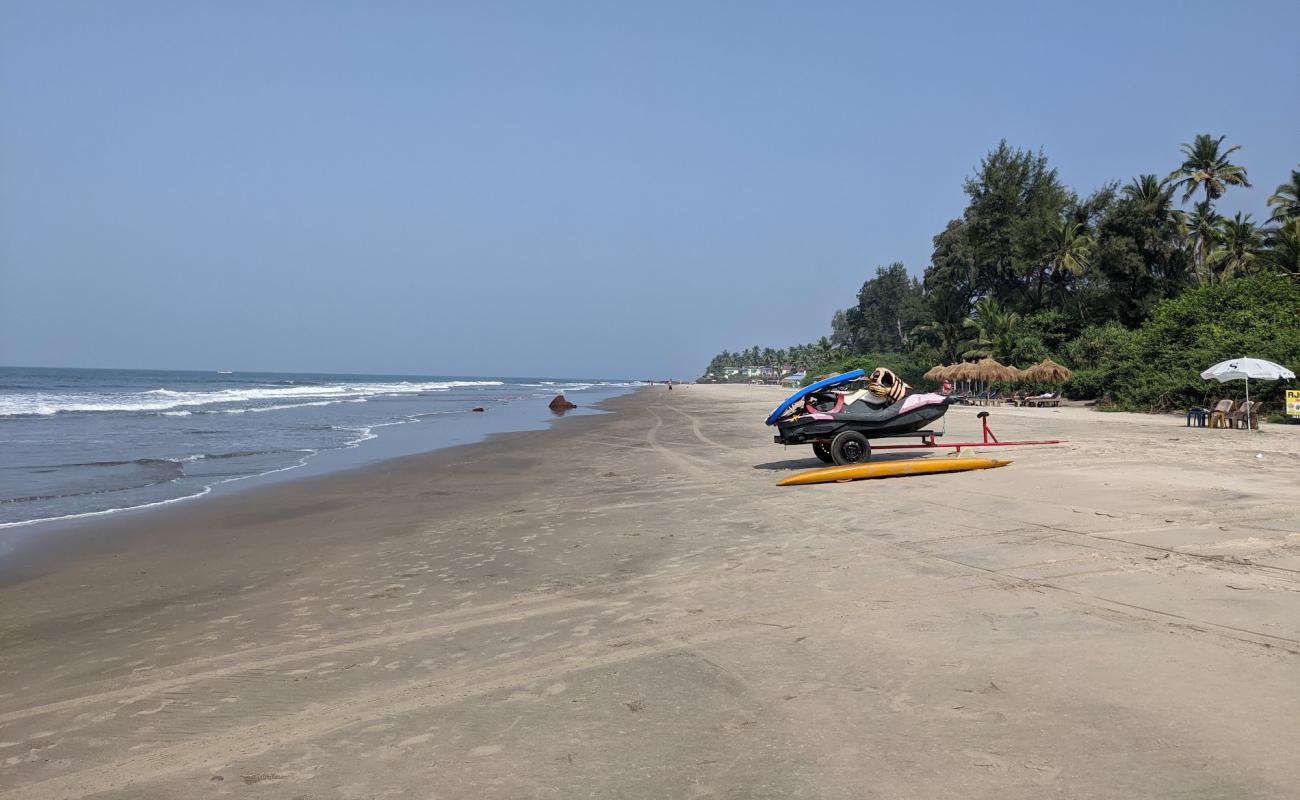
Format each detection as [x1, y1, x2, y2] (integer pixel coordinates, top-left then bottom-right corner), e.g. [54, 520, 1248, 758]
[0, 0, 1300, 379]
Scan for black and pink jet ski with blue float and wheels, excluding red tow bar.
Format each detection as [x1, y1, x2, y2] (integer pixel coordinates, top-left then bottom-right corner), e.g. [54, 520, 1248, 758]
[767, 368, 957, 464]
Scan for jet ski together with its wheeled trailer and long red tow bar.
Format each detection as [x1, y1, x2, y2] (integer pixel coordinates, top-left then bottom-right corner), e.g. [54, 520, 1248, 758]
[767, 369, 1065, 466]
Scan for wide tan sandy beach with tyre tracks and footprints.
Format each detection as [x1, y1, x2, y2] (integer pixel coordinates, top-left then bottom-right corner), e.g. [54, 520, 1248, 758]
[0, 386, 1300, 800]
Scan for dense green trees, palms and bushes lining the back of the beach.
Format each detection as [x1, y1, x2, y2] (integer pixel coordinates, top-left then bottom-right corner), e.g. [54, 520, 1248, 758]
[707, 134, 1300, 408]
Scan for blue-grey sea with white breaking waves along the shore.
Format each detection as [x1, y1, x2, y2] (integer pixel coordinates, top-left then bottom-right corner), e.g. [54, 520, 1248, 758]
[0, 367, 640, 528]
